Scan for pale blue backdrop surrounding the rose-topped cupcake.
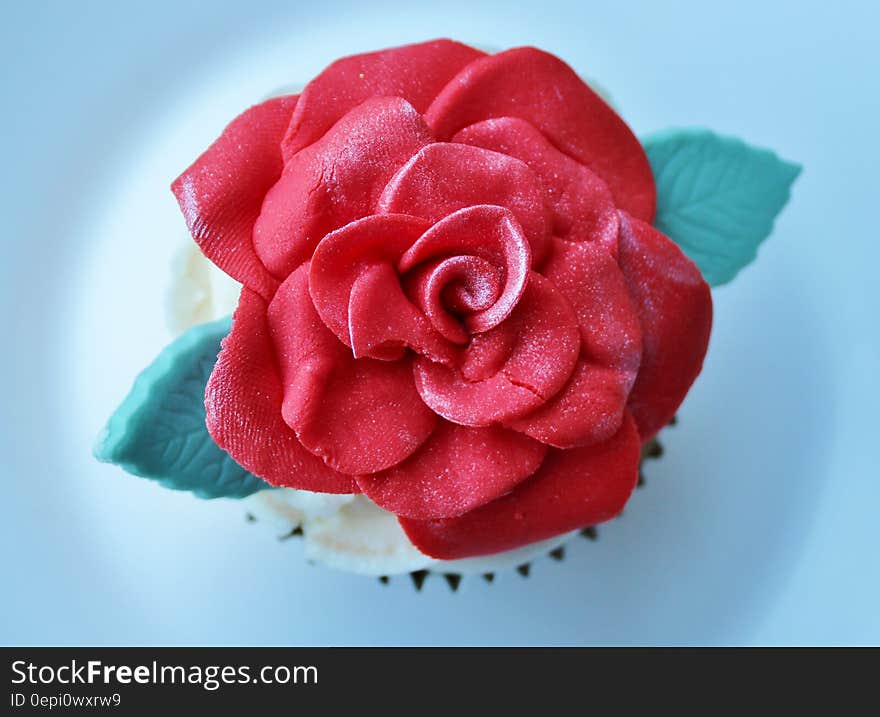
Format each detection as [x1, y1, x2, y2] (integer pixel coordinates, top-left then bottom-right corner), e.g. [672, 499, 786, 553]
[0, 0, 880, 644]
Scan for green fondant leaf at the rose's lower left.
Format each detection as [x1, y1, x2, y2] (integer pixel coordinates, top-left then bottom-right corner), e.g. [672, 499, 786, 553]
[94, 318, 269, 498]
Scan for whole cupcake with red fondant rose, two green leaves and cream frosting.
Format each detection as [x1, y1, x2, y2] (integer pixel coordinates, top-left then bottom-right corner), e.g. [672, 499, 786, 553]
[95, 40, 799, 588]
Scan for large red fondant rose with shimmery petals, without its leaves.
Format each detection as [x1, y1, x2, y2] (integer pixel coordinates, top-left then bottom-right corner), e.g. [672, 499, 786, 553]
[173, 40, 712, 558]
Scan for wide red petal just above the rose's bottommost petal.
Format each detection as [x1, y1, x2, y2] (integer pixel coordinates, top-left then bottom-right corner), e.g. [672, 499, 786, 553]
[357, 421, 547, 520]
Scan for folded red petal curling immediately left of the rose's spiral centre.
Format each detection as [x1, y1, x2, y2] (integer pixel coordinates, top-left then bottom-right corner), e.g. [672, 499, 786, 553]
[309, 214, 451, 361]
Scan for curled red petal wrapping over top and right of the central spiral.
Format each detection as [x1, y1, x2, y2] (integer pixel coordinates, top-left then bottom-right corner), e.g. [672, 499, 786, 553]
[398, 205, 532, 332]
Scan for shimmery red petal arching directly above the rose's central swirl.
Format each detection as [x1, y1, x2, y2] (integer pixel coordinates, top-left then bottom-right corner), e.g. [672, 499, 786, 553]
[378, 142, 550, 264]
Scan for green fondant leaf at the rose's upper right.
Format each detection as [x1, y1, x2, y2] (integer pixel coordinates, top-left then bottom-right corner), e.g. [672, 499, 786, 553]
[643, 129, 801, 286]
